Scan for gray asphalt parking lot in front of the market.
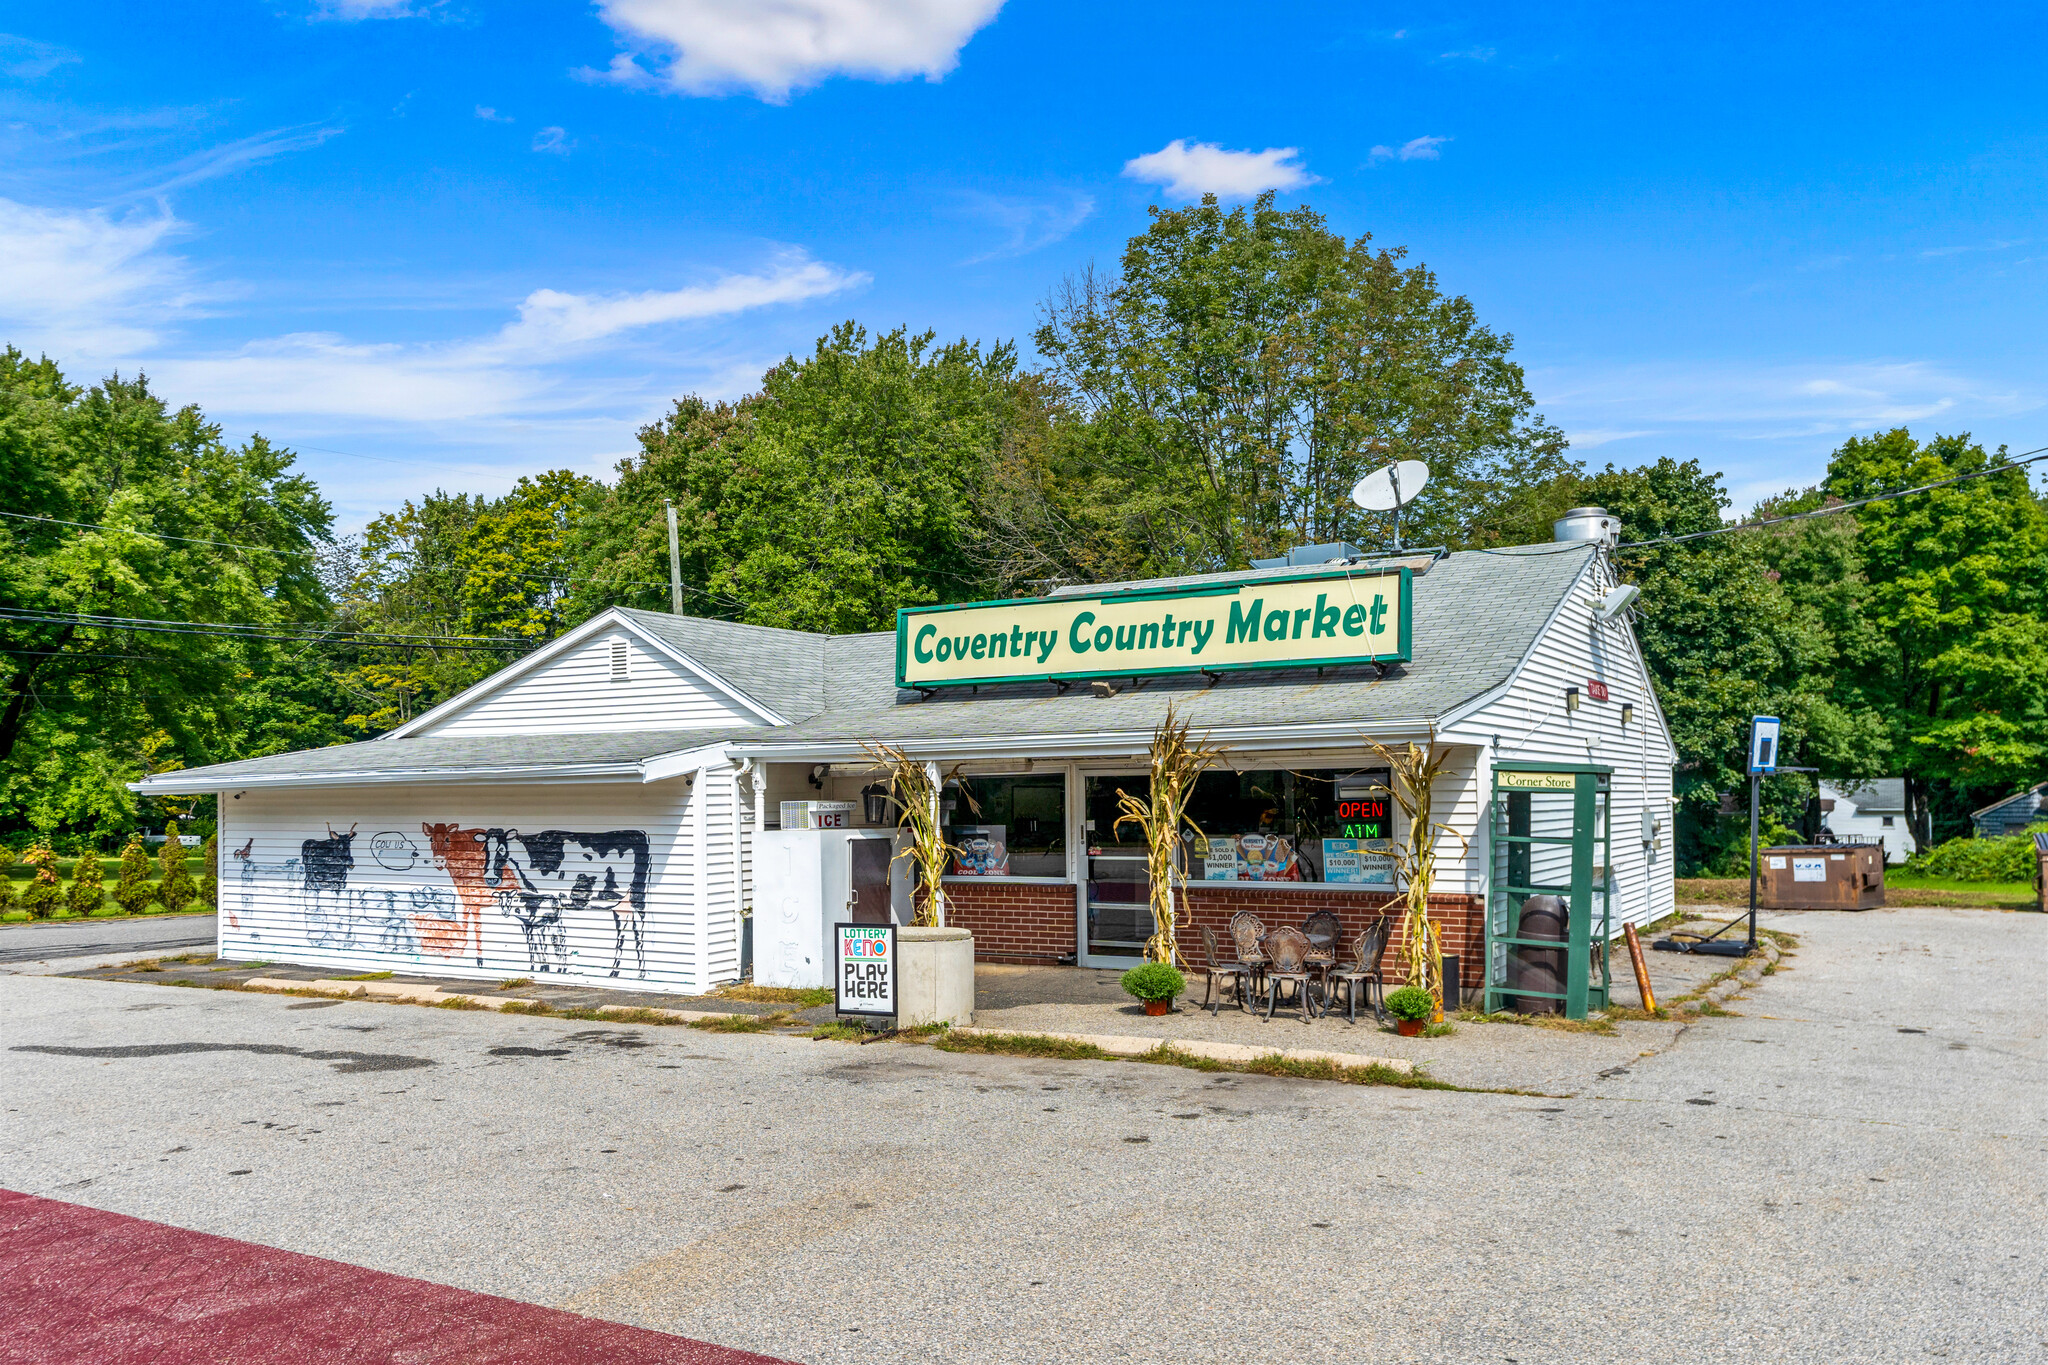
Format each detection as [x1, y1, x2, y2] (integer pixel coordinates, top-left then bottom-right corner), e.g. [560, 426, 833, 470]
[0, 911, 2048, 1365]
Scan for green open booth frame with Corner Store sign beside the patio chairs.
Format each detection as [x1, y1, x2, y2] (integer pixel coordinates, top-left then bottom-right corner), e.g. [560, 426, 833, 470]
[1485, 763, 1614, 1019]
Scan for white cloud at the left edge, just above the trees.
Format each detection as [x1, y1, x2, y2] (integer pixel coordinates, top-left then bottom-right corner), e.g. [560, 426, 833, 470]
[0, 199, 199, 356]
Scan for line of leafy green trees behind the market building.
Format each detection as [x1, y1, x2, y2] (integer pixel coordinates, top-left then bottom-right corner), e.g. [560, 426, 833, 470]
[0, 196, 2048, 872]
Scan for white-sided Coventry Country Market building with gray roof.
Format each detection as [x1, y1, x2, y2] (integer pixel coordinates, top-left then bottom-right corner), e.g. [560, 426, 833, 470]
[135, 523, 1673, 1015]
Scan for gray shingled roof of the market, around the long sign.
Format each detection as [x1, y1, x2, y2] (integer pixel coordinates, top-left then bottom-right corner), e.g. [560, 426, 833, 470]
[136, 546, 1593, 790]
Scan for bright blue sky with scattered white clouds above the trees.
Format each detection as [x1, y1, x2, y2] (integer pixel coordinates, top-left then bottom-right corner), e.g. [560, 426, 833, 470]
[0, 0, 2048, 526]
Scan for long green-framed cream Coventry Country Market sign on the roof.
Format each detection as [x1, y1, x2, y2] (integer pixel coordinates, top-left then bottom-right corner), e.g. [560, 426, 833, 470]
[897, 567, 1413, 688]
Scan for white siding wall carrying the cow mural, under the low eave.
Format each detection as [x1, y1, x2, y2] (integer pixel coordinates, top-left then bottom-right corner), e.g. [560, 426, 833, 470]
[219, 780, 708, 995]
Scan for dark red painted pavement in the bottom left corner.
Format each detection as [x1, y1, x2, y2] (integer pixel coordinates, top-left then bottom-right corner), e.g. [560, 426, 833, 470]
[0, 1189, 788, 1365]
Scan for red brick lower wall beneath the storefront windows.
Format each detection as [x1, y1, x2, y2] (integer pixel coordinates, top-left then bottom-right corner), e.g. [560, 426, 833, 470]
[946, 882, 1487, 993]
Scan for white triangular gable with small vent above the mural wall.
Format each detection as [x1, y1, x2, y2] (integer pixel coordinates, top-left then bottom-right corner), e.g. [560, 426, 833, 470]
[416, 630, 760, 735]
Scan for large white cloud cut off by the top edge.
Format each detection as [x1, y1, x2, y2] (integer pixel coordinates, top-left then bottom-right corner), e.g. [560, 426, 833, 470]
[582, 0, 1004, 104]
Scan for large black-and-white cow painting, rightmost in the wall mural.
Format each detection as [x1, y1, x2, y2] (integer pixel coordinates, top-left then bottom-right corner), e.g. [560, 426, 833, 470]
[483, 829, 647, 976]
